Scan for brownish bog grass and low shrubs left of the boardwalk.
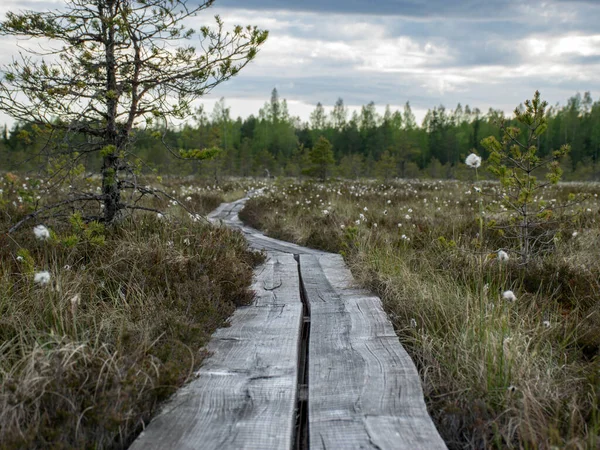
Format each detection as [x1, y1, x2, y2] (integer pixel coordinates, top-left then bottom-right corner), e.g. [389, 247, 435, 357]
[0, 173, 261, 448]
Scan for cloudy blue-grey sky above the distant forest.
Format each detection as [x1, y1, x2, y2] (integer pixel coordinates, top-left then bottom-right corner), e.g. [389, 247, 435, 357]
[0, 0, 600, 126]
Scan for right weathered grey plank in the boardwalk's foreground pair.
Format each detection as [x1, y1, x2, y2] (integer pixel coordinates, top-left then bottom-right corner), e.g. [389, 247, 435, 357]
[300, 255, 446, 449]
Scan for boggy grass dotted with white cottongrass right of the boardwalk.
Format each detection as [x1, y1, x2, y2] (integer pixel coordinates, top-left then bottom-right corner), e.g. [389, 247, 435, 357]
[240, 180, 600, 449]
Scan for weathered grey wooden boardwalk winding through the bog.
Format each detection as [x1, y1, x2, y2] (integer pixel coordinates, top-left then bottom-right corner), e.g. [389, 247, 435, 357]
[130, 199, 446, 450]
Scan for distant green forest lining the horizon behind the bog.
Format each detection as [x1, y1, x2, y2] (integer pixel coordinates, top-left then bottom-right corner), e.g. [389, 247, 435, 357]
[0, 89, 600, 181]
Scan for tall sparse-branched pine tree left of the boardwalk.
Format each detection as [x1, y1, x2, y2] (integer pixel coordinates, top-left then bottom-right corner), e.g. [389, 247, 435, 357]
[0, 0, 267, 223]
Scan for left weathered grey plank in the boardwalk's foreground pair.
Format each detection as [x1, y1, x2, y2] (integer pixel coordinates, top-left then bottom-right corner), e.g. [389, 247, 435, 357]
[131, 253, 302, 450]
